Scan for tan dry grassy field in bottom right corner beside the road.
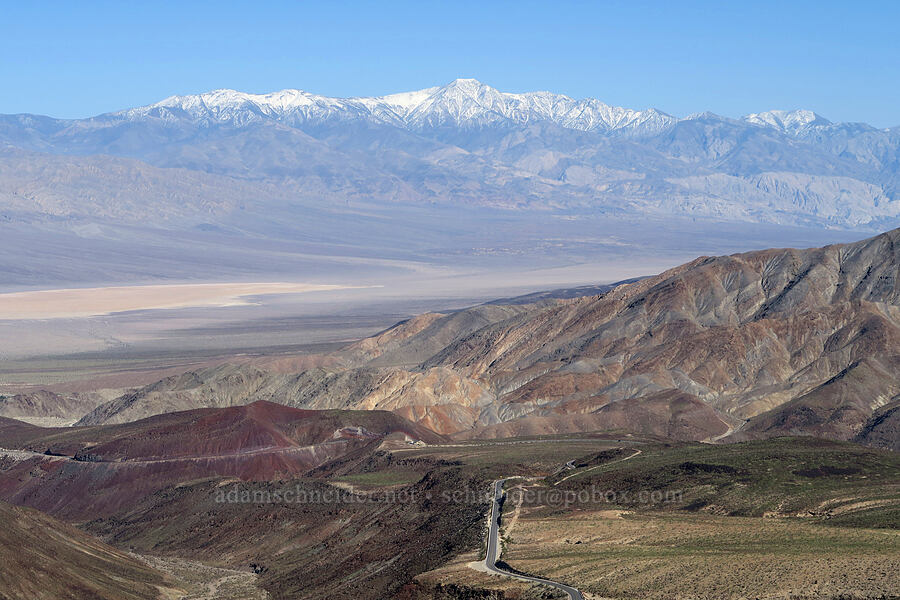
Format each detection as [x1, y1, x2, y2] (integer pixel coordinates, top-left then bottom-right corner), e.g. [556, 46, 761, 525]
[506, 511, 900, 600]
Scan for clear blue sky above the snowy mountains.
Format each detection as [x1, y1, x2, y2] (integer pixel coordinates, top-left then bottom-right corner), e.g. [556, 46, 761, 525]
[0, 0, 900, 127]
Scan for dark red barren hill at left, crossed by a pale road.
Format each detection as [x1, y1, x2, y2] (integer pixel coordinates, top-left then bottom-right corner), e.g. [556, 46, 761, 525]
[0, 402, 444, 521]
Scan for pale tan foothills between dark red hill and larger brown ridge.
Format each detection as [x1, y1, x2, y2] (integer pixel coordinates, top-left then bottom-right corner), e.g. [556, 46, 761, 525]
[78, 306, 533, 433]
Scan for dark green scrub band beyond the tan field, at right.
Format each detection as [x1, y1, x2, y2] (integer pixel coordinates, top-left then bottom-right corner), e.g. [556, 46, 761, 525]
[549, 438, 900, 523]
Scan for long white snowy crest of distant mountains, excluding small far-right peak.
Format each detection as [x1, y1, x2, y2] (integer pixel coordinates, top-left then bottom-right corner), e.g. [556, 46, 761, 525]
[109, 79, 676, 135]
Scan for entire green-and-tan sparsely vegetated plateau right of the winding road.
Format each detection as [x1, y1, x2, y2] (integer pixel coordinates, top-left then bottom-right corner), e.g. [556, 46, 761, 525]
[414, 438, 900, 600]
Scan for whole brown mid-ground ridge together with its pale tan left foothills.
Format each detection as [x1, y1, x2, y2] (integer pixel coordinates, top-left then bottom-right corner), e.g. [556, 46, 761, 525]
[65, 230, 900, 439]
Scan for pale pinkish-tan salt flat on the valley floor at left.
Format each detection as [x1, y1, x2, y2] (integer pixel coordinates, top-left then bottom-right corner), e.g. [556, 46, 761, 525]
[0, 282, 349, 320]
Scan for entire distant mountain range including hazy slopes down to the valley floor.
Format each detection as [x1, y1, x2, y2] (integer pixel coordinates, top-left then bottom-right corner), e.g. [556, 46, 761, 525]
[0, 79, 900, 284]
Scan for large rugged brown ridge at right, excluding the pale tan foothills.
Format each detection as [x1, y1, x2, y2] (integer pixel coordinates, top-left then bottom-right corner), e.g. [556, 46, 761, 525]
[423, 231, 900, 437]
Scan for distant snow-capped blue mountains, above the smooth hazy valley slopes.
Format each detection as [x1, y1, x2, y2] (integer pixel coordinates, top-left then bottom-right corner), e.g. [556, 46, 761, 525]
[0, 79, 900, 244]
